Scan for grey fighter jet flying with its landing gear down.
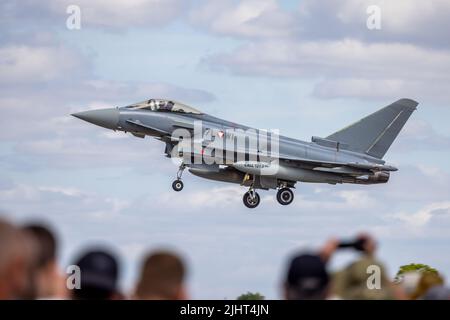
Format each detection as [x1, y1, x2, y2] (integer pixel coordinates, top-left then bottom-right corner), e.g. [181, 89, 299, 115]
[72, 99, 418, 208]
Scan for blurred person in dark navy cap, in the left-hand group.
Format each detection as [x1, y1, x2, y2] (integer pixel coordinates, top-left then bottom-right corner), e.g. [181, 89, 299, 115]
[72, 250, 123, 300]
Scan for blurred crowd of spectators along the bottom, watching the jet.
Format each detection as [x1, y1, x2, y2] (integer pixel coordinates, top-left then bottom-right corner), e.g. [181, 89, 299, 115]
[0, 218, 450, 300]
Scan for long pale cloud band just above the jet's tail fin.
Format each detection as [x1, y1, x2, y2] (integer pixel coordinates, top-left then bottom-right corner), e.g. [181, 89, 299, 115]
[204, 39, 450, 101]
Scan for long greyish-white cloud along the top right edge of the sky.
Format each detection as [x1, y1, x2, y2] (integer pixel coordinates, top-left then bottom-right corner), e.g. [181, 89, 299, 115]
[190, 0, 450, 47]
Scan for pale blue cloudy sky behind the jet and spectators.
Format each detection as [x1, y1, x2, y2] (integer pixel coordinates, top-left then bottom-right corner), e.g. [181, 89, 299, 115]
[0, 0, 450, 299]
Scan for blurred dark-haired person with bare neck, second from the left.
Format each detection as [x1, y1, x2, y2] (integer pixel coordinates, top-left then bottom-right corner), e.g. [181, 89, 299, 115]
[23, 224, 67, 299]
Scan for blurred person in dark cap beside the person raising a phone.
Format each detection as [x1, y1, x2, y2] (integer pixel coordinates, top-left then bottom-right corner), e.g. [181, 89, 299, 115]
[284, 239, 337, 300]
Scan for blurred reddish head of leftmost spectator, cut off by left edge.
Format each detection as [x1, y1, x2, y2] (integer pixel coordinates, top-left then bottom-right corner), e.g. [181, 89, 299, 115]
[0, 219, 31, 300]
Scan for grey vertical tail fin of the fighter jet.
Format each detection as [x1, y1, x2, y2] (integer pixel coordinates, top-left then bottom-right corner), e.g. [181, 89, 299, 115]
[326, 99, 418, 159]
